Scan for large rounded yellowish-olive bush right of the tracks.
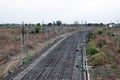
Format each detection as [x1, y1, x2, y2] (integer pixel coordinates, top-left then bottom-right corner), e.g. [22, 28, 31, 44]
[89, 52, 107, 67]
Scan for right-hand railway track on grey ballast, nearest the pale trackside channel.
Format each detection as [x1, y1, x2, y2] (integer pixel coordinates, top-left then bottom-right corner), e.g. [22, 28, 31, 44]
[43, 33, 79, 80]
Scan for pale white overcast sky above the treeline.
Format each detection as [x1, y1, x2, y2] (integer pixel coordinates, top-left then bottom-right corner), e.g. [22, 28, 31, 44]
[0, 0, 120, 23]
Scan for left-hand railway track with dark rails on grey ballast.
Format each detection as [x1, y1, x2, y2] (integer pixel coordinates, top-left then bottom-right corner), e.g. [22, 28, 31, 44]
[34, 34, 74, 80]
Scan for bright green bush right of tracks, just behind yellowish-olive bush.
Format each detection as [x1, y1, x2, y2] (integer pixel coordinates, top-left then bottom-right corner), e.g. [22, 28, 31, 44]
[87, 41, 97, 55]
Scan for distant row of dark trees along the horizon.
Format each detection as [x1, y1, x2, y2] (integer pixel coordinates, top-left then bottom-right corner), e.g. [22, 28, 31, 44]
[0, 20, 120, 27]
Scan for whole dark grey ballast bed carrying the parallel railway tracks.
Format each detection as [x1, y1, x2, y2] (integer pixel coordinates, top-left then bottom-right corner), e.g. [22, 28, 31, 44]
[15, 32, 84, 80]
